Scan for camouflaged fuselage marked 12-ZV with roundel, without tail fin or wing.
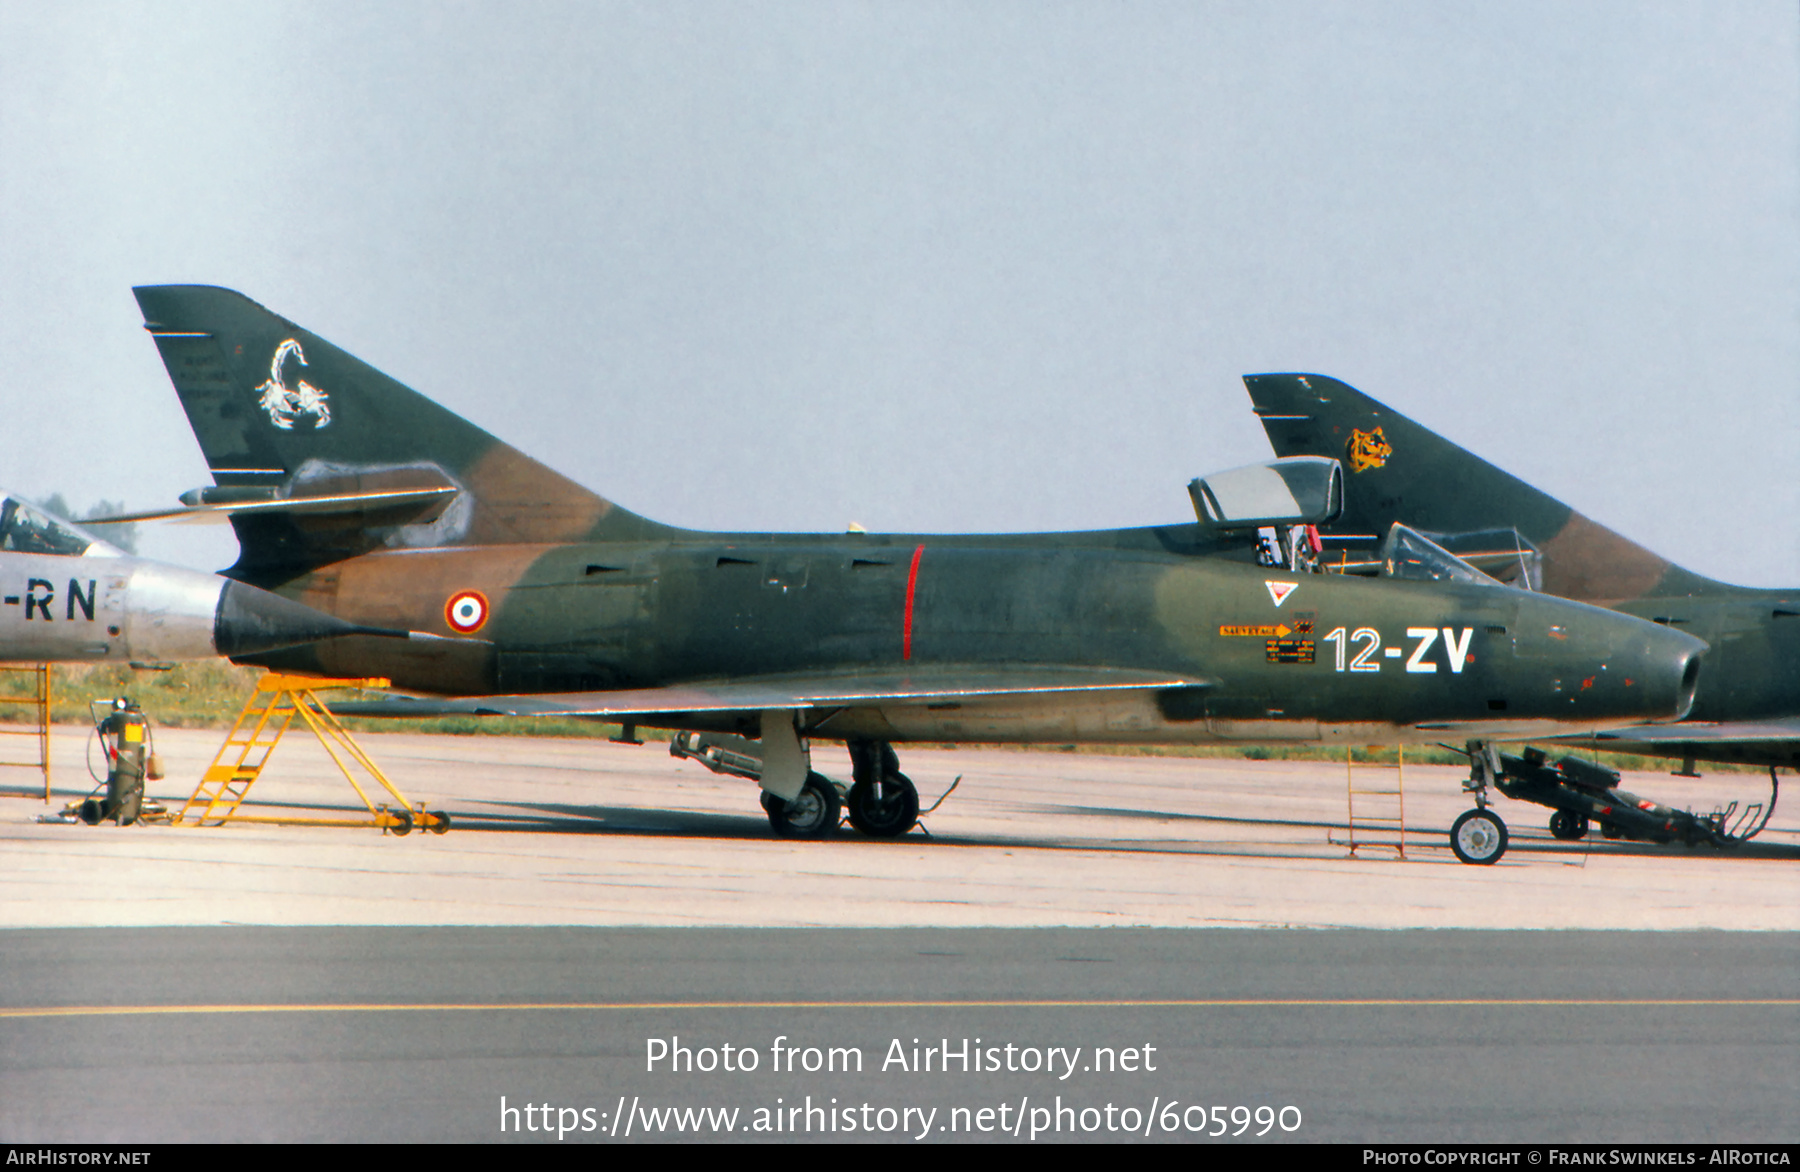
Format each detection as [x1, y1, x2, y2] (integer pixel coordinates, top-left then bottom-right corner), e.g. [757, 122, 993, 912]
[239, 535, 1699, 744]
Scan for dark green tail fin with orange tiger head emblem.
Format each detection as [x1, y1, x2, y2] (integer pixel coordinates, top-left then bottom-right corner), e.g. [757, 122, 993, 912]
[1244, 374, 1708, 601]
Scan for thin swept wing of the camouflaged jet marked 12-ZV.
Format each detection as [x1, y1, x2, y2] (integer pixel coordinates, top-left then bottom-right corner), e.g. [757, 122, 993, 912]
[331, 664, 1215, 717]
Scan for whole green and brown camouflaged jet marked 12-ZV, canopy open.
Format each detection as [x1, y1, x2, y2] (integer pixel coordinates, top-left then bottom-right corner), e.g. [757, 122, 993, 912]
[119, 286, 1703, 861]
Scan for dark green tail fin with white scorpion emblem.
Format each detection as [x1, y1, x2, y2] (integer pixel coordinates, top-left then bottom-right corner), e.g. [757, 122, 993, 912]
[133, 284, 670, 583]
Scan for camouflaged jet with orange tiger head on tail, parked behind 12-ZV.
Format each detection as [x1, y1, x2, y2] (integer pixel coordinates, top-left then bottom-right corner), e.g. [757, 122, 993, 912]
[1244, 374, 1800, 774]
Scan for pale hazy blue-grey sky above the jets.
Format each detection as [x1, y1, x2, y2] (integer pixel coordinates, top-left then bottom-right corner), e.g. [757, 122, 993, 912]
[0, 0, 1800, 585]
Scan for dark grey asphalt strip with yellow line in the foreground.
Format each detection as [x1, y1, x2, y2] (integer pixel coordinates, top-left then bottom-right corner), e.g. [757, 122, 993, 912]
[0, 927, 1800, 1143]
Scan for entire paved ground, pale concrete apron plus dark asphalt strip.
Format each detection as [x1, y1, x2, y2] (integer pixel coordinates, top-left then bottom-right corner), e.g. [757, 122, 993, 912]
[0, 729, 1800, 1143]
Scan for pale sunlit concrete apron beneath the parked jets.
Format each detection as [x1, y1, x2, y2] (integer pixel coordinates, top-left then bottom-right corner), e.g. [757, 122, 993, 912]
[0, 727, 1800, 931]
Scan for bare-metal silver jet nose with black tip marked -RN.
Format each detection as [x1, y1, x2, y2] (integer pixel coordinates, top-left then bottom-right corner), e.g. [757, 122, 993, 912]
[0, 491, 406, 666]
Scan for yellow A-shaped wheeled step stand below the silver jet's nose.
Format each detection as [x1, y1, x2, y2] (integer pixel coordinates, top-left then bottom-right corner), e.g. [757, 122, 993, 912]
[173, 672, 450, 835]
